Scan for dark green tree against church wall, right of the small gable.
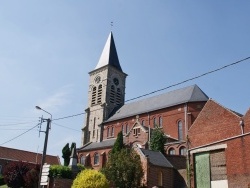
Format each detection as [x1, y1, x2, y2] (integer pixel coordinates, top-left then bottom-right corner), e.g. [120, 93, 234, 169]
[150, 127, 166, 154]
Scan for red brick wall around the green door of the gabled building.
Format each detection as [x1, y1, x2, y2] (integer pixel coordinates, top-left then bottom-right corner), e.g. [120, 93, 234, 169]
[188, 100, 250, 187]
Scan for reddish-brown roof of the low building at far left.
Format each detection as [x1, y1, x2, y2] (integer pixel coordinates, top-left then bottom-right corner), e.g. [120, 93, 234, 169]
[0, 146, 61, 165]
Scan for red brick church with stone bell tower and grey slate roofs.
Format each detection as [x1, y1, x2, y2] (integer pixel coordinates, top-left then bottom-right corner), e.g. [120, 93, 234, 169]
[77, 32, 209, 187]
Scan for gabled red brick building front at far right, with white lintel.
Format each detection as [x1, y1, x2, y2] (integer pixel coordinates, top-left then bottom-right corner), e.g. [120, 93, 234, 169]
[188, 100, 250, 187]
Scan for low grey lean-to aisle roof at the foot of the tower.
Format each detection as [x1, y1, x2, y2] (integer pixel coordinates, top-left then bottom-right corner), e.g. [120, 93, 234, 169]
[77, 138, 116, 151]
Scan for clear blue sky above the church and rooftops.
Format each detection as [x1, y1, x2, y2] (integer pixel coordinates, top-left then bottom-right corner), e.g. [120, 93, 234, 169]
[0, 0, 250, 162]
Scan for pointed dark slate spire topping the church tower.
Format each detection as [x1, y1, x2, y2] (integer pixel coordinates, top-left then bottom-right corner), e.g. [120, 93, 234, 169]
[95, 32, 122, 71]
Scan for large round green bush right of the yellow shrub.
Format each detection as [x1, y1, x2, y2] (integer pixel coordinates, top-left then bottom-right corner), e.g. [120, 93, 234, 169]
[102, 149, 143, 188]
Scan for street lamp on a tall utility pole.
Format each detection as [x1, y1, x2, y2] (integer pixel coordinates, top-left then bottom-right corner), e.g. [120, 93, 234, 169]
[36, 106, 52, 187]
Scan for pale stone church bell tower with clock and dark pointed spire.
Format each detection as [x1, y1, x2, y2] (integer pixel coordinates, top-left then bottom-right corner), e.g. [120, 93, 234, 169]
[82, 32, 127, 145]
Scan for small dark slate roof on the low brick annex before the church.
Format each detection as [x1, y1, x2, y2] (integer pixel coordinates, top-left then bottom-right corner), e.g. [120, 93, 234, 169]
[139, 148, 173, 168]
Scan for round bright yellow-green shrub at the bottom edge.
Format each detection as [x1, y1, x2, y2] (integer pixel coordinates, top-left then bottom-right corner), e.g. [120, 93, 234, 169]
[71, 169, 109, 188]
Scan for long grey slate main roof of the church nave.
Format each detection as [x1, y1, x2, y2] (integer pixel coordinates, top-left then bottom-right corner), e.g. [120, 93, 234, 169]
[105, 85, 209, 122]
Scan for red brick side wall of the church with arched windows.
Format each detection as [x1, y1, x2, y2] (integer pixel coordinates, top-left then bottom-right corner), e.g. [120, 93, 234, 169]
[78, 102, 205, 169]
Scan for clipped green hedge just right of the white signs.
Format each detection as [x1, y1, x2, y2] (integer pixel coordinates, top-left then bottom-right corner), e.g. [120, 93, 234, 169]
[49, 165, 73, 179]
